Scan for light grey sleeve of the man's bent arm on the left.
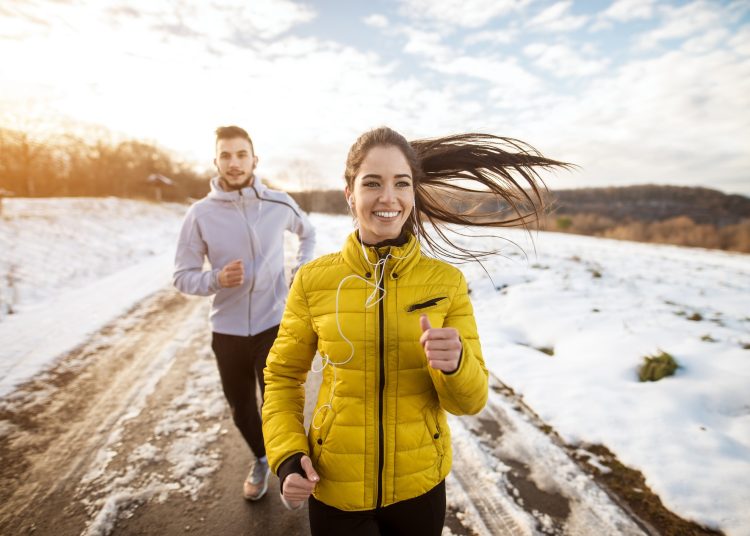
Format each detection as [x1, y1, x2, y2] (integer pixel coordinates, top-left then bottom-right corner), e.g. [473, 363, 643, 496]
[172, 207, 221, 296]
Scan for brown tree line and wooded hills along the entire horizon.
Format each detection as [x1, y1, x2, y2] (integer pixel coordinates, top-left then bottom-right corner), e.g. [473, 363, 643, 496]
[0, 128, 750, 253]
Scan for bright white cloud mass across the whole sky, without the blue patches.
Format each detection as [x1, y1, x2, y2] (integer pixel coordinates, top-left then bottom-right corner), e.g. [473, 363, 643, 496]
[0, 0, 750, 195]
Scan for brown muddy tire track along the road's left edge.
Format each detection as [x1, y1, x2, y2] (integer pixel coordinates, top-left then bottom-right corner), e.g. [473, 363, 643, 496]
[0, 289, 212, 534]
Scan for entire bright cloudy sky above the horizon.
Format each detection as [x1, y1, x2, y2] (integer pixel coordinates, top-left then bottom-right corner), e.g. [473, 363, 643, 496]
[0, 0, 750, 195]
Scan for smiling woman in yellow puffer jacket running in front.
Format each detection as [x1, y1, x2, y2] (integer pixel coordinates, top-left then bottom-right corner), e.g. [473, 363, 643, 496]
[263, 127, 565, 535]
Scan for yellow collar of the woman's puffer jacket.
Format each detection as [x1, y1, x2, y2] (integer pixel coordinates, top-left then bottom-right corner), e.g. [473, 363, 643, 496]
[341, 231, 421, 279]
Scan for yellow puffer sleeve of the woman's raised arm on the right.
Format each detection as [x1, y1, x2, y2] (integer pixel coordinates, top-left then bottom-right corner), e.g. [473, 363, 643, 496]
[428, 272, 489, 415]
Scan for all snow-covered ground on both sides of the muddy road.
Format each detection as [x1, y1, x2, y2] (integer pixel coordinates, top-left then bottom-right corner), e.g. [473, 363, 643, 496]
[0, 199, 750, 535]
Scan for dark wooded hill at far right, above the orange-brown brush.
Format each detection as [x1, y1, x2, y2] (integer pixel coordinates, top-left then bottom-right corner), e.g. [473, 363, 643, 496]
[550, 184, 750, 227]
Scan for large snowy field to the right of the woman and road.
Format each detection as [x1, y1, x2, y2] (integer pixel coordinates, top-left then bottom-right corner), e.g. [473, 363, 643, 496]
[464, 228, 750, 534]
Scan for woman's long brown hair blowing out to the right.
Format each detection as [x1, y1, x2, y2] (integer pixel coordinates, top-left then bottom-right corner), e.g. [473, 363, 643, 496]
[344, 127, 572, 261]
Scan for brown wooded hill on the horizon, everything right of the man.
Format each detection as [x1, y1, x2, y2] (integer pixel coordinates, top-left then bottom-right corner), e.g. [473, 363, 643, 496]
[291, 184, 750, 253]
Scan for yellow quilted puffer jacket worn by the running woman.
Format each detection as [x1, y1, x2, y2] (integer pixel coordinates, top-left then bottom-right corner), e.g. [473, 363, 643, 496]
[263, 233, 488, 510]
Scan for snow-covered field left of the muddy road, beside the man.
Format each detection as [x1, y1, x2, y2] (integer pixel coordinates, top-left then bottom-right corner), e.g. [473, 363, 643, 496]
[0, 198, 185, 396]
